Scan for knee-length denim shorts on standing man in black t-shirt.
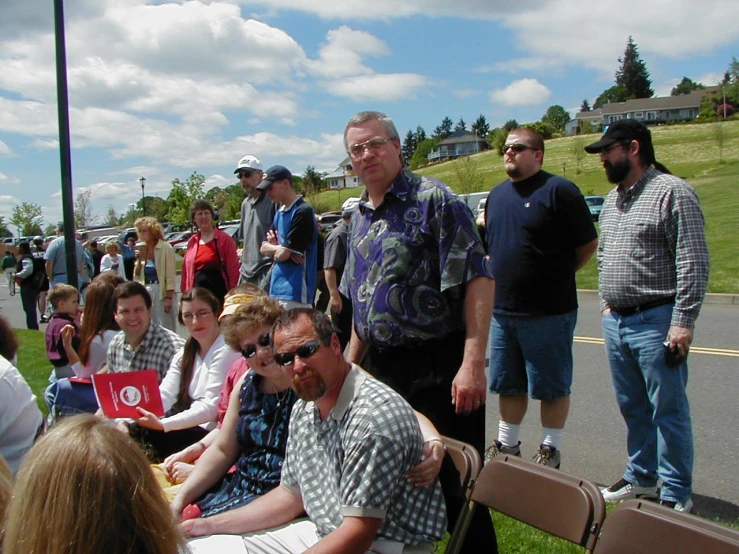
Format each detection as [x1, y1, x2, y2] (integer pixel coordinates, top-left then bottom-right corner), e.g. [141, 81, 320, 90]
[488, 310, 577, 400]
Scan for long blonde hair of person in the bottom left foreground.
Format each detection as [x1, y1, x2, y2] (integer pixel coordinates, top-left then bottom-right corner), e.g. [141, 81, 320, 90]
[4, 415, 184, 554]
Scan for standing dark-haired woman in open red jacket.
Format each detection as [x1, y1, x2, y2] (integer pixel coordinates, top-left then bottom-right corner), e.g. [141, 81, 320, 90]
[181, 200, 239, 306]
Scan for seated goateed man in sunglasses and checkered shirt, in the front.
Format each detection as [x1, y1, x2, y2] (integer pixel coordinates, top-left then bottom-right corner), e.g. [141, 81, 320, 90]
[188, 308, 446, 554]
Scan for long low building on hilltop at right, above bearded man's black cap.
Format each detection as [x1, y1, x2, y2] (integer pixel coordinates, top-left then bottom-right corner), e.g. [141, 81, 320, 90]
[567, 87, 718, 135]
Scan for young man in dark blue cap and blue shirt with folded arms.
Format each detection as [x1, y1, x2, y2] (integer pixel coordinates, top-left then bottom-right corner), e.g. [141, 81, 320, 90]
[256, 165, 318, 309]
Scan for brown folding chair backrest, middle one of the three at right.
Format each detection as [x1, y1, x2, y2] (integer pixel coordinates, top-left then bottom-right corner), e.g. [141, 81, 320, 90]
[472, 456, 605, 551]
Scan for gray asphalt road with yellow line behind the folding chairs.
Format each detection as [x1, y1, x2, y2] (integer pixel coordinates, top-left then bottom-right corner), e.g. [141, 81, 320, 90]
[0, 279, 739, 521]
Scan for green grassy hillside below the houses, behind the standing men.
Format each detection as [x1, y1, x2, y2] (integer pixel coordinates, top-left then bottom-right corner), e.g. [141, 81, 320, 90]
[318, 121, 739, 293]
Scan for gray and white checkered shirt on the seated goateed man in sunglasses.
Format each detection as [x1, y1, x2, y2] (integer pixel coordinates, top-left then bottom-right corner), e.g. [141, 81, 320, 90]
[282, 365, 446, 545]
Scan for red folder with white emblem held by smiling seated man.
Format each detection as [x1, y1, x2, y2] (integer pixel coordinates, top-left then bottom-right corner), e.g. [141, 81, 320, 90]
[92, 369, 164, 418]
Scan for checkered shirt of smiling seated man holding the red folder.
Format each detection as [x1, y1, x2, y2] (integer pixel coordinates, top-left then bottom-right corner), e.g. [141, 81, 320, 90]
[108, 321, 185, 383]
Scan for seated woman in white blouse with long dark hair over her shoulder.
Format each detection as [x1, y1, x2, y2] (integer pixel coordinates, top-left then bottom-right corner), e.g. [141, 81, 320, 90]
[129, 287, 240, 462]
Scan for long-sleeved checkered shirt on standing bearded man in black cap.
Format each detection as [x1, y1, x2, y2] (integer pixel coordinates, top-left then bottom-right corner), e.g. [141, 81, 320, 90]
[598, 167, 709, 329]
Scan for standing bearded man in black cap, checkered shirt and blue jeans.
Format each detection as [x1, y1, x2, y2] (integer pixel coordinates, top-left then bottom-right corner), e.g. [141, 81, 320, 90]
[585, 119, 709, 512]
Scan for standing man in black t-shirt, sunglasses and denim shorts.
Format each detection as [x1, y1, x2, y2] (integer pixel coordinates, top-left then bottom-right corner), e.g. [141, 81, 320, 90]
[485, 128, 598, 468]
